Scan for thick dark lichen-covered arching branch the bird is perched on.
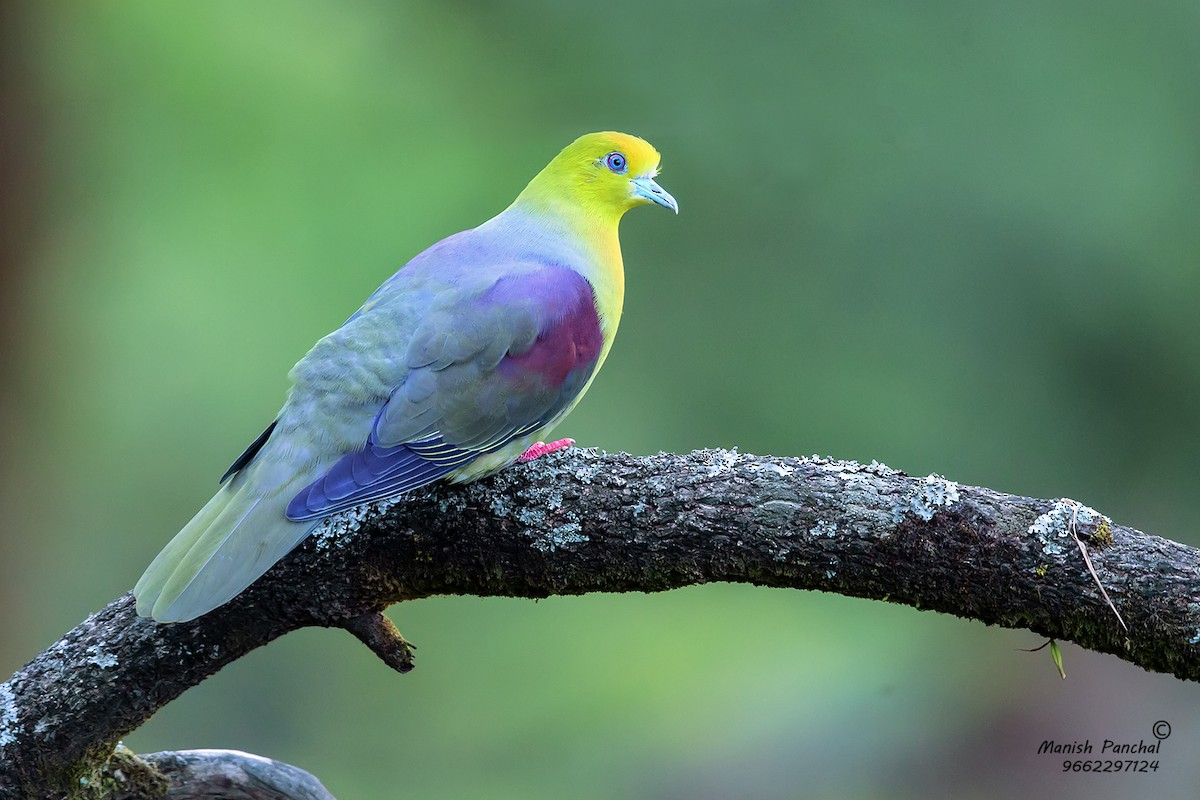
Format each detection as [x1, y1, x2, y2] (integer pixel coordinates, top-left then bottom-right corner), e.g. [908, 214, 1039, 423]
[0, 450, 1200, 798]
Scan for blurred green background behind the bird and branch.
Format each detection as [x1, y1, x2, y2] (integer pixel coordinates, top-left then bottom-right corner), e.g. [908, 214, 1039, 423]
[0, 0, 1200, 800]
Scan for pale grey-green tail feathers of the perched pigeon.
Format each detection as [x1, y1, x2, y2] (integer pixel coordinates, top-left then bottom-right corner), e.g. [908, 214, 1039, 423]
[133, 475, 316, 622]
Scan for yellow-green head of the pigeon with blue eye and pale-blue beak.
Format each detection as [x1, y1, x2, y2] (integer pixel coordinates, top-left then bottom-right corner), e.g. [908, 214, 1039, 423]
[517, 131, 679, 223]
